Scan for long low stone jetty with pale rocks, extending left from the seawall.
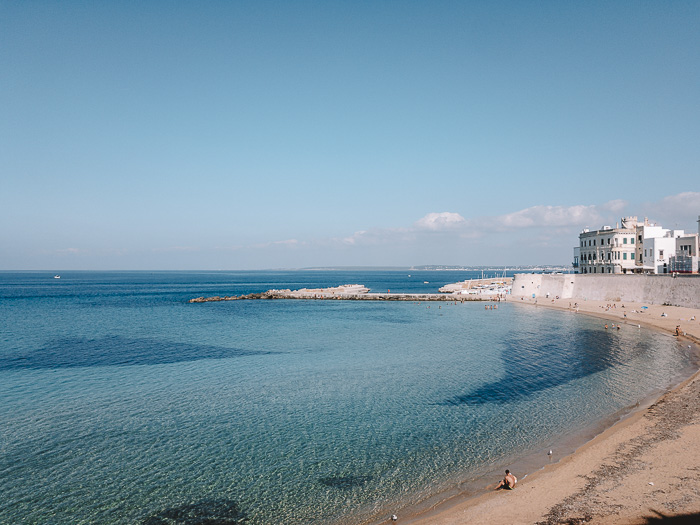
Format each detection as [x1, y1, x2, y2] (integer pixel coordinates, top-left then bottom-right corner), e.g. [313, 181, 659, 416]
[189, 284, 505, 303]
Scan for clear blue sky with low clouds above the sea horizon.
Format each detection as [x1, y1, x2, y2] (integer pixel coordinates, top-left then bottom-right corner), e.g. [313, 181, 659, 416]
[0, 0, 700, 269]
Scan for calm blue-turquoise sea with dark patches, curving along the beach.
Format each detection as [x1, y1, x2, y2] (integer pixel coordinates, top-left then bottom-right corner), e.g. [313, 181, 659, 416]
[0, 272, 695, 524]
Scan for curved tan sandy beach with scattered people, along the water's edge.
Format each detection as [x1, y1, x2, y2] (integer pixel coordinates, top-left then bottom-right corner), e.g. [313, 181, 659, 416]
[398, 298, 700, 525]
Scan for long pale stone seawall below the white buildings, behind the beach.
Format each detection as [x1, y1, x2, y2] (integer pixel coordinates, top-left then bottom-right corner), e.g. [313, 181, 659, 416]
[512, 273, 700, 308]
